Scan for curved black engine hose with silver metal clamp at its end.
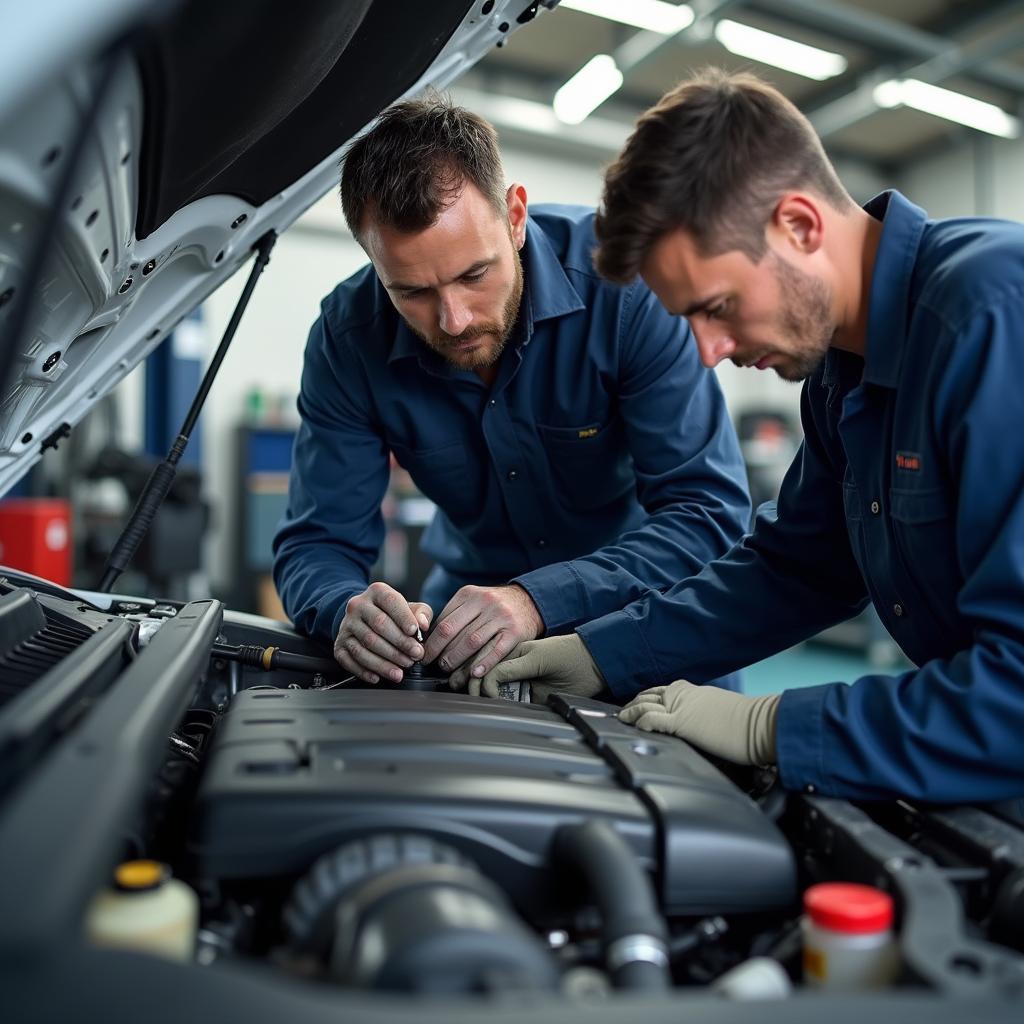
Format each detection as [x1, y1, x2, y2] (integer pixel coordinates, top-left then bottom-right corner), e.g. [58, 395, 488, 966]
[554, 821, 671, 991]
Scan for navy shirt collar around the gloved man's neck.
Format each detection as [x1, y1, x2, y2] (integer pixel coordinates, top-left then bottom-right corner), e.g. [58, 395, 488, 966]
[863, 190, 928, 388]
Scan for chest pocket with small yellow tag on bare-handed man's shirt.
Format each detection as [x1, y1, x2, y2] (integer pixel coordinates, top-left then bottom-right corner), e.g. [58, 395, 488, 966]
[537, 420, 636, 511]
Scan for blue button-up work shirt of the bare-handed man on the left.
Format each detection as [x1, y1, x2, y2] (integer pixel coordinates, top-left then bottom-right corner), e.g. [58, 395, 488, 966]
[273, 206, 750, 659]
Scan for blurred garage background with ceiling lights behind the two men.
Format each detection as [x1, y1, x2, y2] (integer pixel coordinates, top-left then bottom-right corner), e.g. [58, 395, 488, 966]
[9, 0, 1024, 692]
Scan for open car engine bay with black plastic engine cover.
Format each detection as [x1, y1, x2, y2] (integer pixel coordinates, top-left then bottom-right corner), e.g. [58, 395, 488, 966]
[0, 572, 1024, 1020]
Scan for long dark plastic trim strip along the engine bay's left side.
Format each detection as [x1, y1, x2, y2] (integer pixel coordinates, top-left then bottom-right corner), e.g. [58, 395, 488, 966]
[0, 601, 222, 959]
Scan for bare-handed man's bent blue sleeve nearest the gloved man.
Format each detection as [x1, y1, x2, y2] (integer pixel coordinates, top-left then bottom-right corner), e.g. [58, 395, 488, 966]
[514, 284, 751, 633]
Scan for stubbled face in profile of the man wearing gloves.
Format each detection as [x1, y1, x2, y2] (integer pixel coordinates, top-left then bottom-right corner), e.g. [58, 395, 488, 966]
[641, 230, 837, 381]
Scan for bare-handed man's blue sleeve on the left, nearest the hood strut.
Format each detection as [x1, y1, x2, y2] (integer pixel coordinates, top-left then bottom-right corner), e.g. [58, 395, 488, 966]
[273, 314, 389, 641]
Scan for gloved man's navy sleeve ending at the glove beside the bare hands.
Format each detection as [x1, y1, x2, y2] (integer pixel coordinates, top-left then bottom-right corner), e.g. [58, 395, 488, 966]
[577, 372, 867, 699]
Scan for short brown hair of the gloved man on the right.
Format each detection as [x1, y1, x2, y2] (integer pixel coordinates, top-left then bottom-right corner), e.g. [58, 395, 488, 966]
[594, 69, 853, 283]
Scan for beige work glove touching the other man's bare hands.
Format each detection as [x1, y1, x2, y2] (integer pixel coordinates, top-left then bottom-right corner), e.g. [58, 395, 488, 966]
[469, 633, 605, 703]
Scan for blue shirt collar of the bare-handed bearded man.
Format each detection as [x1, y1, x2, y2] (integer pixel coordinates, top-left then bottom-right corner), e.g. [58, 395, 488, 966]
[387, 209, 586, 364]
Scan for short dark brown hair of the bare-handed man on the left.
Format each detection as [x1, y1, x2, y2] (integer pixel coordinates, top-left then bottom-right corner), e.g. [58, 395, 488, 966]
[341, 94, 506, 238]
